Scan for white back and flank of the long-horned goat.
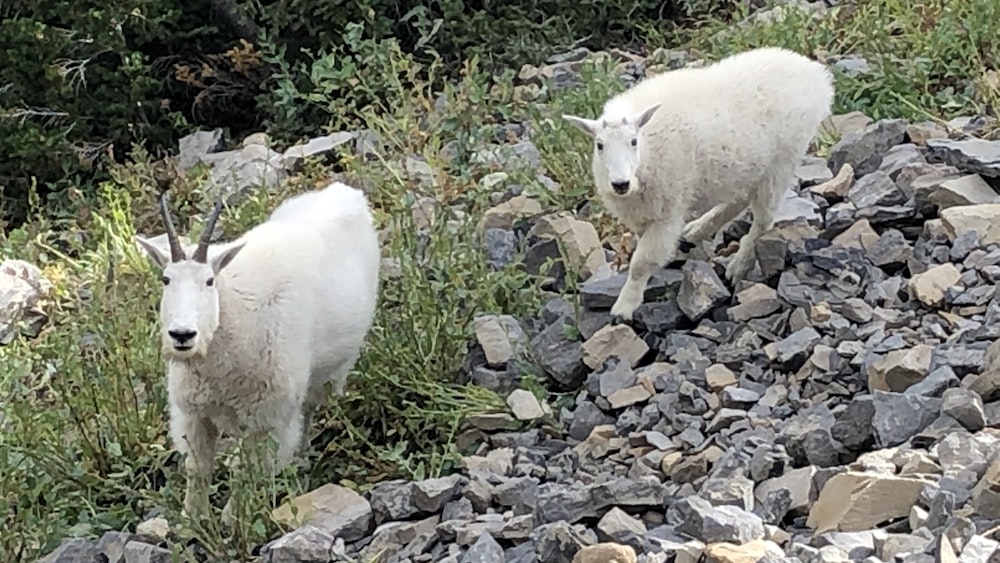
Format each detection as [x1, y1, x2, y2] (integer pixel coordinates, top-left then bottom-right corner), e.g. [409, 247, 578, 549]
[224, 182, 381, 365]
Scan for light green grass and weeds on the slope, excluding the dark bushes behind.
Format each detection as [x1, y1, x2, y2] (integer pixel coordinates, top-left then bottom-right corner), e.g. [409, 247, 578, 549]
[0, 0, 1000, 561]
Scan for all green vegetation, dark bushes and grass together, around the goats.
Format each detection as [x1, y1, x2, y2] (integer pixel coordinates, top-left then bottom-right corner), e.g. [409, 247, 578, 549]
[0, 0, 1000, 561]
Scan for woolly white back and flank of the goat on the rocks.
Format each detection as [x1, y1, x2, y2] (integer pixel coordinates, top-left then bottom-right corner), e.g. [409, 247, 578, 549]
[605, 47, 834, 216]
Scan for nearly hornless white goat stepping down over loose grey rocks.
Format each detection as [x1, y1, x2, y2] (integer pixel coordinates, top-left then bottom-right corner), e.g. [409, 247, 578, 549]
[563, 47, 834, 319]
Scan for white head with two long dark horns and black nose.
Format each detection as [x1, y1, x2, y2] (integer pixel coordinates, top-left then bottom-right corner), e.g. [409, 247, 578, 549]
[136, 195, 245, 359]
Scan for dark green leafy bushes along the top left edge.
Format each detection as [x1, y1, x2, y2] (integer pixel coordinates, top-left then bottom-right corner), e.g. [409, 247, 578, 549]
[0, 0, 736, 229]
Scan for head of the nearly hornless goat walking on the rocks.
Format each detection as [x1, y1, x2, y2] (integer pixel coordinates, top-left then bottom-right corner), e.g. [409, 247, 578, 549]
[563, 104, 660, 196]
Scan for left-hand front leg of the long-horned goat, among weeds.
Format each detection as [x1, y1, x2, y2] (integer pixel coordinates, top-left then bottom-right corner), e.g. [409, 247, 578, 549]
[172, 412, 219, 518]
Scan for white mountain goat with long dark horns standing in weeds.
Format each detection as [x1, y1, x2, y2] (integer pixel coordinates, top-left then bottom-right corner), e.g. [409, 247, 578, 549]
[136, 182, 381, 521]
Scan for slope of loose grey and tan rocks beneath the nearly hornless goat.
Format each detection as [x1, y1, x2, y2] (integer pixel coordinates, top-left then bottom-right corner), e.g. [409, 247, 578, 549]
[29, 49, 1000, 563]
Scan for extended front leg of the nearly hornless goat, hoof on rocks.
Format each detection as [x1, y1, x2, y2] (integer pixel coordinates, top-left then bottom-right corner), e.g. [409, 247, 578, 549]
[611, 214, 684, 321]
